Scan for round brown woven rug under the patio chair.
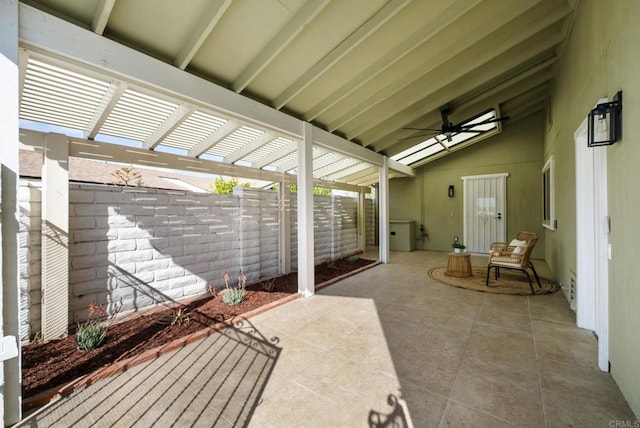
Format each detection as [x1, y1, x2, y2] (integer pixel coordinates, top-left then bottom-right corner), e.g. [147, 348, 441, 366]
[429, 266, 560, 296]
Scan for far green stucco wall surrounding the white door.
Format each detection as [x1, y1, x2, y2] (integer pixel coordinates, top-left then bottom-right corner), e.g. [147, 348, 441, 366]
[389, 113, 545, 258]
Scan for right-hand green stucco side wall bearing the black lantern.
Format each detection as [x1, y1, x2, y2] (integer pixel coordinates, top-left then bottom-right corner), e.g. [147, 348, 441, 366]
[544, 0, 640, 416]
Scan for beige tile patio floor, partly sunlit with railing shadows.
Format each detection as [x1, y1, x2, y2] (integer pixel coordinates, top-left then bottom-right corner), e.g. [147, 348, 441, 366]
[17, 252, 635, 427]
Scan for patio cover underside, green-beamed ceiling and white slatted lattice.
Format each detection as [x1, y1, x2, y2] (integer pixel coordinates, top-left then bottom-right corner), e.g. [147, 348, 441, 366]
[21, 0, 574, 184]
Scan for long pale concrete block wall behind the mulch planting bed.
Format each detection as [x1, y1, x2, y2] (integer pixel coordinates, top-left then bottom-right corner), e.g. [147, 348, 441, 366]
[19, 180, 364, 342]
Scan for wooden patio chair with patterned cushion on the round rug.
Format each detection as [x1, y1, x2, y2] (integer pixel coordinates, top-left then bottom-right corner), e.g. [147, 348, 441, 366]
[486, 232, 542, 294]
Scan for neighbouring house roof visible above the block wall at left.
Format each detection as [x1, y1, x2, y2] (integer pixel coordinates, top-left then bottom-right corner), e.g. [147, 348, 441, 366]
[20, 150, 216, 192]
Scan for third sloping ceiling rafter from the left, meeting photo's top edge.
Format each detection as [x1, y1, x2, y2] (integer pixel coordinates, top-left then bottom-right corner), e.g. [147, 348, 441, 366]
[231, 0, 330, 92]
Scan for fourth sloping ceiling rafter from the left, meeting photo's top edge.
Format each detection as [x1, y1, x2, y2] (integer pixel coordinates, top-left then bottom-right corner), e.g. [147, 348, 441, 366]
[274, 0, 410, 109]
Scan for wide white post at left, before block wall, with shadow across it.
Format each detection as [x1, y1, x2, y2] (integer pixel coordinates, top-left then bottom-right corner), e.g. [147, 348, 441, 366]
[42, 134, 69, 342]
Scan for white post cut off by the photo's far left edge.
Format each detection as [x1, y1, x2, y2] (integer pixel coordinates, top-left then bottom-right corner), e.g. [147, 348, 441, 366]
[0, 0, 22, 426]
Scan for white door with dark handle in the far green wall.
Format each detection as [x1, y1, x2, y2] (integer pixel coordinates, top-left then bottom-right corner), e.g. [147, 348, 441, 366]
[462, 173, 509, 254]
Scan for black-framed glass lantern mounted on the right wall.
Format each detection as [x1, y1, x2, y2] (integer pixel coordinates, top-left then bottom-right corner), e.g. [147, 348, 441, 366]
[587, 91, 622, 147]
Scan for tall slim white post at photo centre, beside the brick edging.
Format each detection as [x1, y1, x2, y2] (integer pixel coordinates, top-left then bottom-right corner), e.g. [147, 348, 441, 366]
[298, 122, 315, 297]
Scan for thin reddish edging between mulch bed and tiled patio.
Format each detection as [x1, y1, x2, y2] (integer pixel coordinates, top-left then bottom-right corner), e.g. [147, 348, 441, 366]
[22, 261, 382, 411]
